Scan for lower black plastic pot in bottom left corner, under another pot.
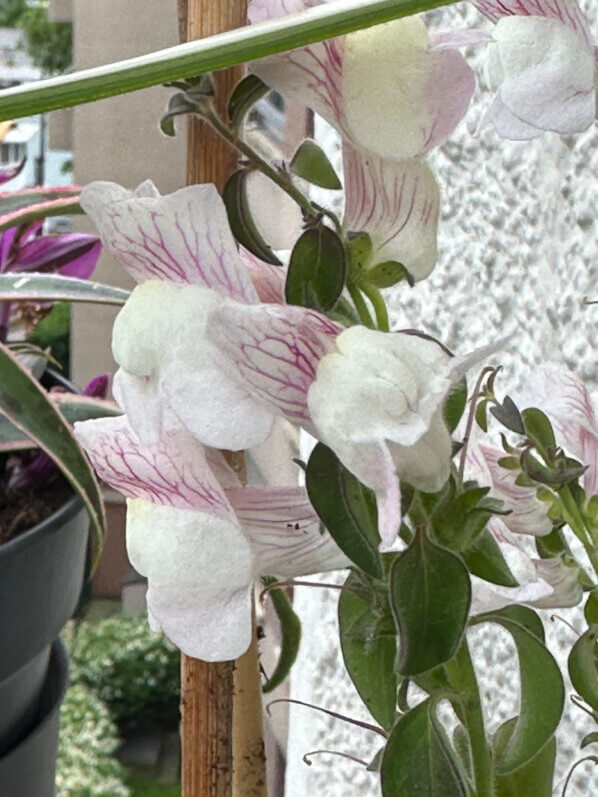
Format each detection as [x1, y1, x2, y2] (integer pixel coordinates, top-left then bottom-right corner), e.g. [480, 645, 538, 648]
[0, 640, 69, 797]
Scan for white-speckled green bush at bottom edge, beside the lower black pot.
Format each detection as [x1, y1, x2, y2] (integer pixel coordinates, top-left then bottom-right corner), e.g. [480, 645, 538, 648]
[56, 684, 130, 797]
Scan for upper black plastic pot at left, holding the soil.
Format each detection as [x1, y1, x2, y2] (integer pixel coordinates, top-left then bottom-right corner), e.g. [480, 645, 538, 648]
[0, 497, 89, 797]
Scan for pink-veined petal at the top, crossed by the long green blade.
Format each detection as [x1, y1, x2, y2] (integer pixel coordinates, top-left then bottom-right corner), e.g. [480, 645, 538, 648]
[249, 0, 346, 133]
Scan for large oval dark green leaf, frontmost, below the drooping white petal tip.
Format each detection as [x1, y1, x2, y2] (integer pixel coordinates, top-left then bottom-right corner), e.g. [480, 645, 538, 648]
[389, 530, 471, 675]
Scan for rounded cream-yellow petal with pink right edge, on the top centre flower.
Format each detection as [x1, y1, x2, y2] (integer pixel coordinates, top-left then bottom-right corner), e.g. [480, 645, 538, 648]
[342, 17, 475, 160]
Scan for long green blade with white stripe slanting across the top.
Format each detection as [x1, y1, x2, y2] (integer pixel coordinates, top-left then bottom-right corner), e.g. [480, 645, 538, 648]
[0, 0, 455, 120]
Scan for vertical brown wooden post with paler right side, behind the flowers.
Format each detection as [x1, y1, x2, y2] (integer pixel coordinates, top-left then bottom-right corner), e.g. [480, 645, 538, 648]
[178, 0, 266, 797]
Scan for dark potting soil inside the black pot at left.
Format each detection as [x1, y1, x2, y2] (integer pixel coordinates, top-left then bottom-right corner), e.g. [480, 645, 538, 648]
[0, 466, 73, 545]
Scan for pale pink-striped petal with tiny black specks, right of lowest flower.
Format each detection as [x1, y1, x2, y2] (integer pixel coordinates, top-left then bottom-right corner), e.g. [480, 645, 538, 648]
[227, 487, 350, 577]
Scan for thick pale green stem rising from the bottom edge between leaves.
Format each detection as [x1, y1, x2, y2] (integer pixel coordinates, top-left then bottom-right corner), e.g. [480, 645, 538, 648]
[444, 637, 494, 797]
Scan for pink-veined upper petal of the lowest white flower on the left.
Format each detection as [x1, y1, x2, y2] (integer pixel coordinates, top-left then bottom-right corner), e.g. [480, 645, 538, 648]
[75, 416, 234, 519]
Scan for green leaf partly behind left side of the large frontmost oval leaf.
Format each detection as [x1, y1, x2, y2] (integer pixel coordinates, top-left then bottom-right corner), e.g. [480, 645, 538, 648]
[338, 573, 398, 730]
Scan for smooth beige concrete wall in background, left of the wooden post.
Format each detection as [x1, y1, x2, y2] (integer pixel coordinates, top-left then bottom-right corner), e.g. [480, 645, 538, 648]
[72, 0, 185, 384]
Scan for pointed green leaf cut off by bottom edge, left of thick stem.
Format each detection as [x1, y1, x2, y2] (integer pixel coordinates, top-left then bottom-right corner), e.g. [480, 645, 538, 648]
[380, 699, 467, 797]
